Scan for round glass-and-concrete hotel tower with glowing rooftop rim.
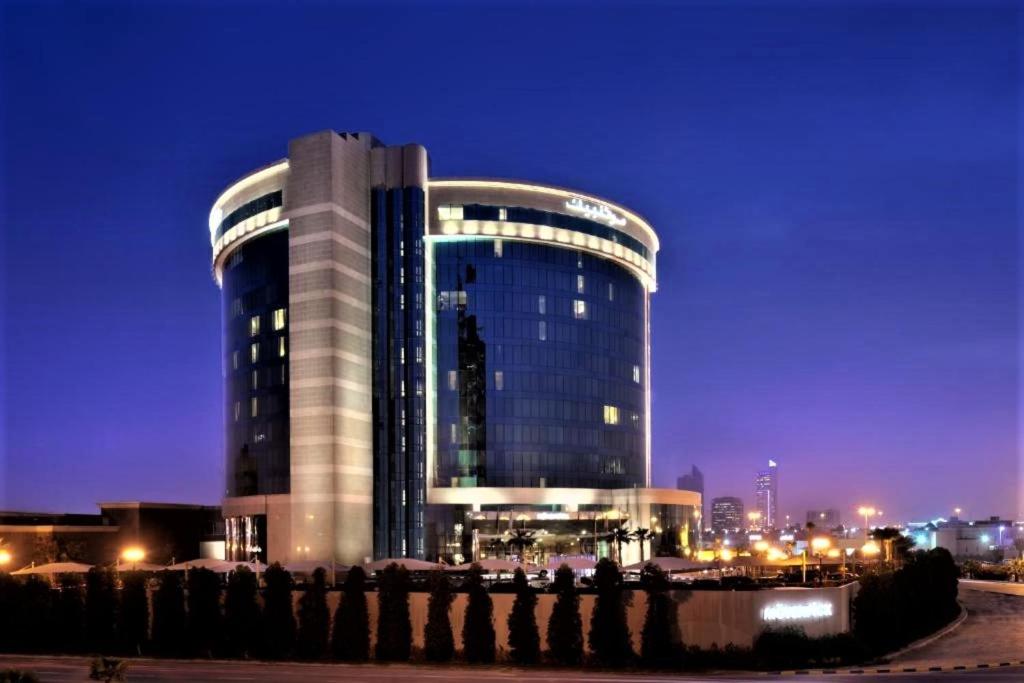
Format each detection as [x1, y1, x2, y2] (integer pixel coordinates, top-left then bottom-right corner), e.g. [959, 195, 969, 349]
[210, 131, 699, 563]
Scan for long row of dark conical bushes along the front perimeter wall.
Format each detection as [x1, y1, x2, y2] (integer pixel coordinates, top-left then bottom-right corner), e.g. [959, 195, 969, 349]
[0, 551, 958, 669]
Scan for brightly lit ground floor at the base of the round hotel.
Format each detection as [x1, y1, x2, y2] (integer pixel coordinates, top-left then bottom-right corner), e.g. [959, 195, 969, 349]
[223, 486, 700, 566]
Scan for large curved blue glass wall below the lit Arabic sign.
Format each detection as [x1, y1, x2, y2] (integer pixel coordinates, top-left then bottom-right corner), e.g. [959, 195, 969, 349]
[434, 239, 646, 488]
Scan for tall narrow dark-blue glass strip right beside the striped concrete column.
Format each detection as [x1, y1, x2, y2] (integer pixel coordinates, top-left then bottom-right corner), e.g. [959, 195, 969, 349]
[371, 187, 426, 557]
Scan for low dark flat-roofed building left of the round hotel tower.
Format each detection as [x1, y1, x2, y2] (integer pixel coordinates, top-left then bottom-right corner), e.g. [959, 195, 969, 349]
[0, 502, 224, 569]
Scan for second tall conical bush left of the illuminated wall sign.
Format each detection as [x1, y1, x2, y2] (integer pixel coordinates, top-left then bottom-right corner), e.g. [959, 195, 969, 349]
[588, 558, 634, 667]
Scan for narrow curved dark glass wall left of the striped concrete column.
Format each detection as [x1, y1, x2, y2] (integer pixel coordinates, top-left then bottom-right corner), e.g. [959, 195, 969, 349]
[222, 230, 289, 497]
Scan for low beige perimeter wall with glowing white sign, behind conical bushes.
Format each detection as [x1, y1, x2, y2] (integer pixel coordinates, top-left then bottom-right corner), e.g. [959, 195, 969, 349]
[295, 583, 858, 651]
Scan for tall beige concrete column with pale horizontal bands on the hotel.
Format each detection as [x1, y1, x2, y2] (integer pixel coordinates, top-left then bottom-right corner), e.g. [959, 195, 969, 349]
[285, 131, 373, 563]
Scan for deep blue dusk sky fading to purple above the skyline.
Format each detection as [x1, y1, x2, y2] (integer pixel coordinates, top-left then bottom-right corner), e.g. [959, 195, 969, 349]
[0, 0, 1024, 521]
